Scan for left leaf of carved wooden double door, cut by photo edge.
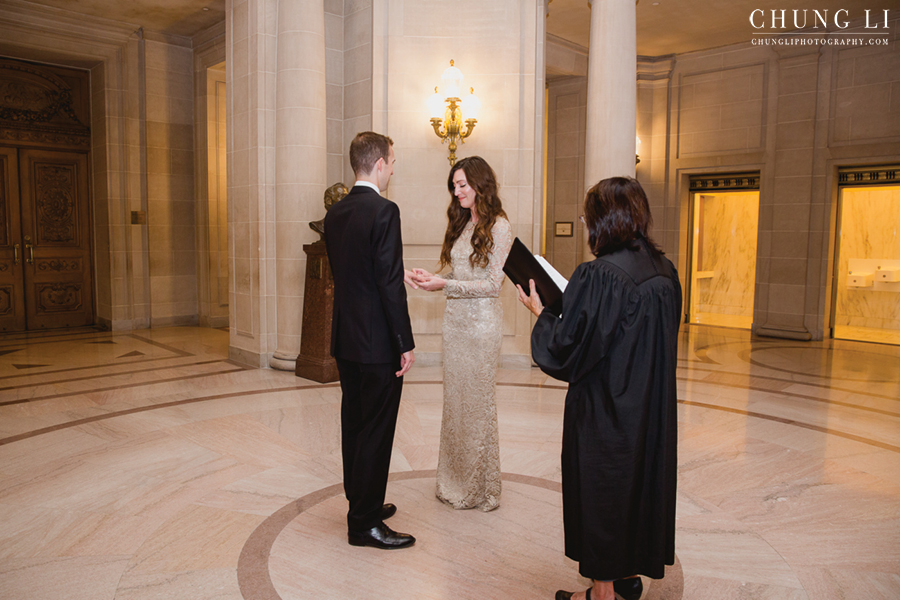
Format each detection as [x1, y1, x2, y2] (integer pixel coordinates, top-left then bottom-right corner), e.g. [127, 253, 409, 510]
[0, 148, 25, 331]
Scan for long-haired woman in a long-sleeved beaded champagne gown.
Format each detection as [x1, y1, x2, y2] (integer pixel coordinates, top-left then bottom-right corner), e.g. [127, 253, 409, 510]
[415, 156, 512, 511]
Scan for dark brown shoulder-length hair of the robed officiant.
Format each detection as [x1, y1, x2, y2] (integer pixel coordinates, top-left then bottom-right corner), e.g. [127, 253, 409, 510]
[584, 177, 663, 256]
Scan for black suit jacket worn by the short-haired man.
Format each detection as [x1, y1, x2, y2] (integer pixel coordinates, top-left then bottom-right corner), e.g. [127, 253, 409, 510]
[325, 186, 415, 364]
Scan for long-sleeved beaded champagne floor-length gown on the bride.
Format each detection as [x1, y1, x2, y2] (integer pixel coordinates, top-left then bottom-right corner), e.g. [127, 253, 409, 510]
[436, 218, 512, 511]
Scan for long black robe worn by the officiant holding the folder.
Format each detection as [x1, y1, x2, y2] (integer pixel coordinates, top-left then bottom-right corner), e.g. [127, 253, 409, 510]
[531, 241, 681, 580]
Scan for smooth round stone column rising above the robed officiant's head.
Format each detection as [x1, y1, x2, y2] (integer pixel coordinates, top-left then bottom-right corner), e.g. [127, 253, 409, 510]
[584, 0, 637, 253]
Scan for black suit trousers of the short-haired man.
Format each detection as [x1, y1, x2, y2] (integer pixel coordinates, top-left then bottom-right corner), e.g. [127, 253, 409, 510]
[337, 357, 403, 532]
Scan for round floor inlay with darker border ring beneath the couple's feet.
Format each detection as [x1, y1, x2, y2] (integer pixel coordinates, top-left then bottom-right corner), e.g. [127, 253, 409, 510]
[238, 471, 683, 600]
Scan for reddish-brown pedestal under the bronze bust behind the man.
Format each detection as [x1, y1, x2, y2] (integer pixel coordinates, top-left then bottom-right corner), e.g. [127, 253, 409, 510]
[294, 242, 338, 383]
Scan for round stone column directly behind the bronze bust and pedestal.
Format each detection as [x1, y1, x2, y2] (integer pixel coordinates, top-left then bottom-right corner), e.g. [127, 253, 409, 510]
[269, 0, 327, 371]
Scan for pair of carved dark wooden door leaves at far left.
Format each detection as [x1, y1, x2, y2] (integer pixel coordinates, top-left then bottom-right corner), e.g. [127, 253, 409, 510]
[0, 148, 94, 331]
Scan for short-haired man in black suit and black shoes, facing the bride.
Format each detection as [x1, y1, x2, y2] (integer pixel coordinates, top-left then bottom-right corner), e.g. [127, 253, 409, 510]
[325, 131, 416, 549]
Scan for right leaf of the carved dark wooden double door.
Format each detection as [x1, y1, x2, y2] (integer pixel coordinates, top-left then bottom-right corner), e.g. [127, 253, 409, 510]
[19, 149, 94, 329]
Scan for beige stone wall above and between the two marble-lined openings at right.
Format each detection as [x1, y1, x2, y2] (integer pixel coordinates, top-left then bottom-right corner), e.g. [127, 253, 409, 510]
[548, 19, 900, 339]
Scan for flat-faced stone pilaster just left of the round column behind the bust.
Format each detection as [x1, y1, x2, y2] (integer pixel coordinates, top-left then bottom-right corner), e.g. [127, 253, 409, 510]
[225, 0, 278, 367]
